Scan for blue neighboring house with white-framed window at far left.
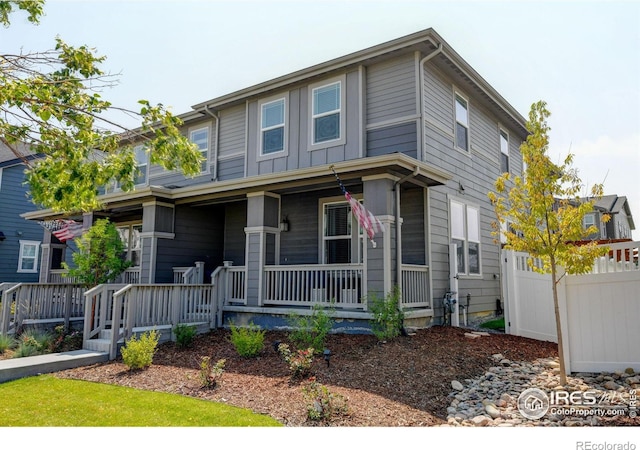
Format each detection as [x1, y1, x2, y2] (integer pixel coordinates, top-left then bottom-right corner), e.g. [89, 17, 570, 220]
[0, 142, 42, 283]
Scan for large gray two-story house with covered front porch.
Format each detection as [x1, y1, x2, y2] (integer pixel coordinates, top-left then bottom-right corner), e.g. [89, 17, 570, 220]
[22, 29, 527, 327]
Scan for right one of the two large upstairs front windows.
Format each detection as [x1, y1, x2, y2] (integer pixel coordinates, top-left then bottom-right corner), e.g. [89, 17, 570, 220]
[312, 81, 342, 144]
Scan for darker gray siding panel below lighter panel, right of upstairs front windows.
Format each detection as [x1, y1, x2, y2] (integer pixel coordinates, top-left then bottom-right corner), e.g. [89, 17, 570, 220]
[367, 122, 418, 158]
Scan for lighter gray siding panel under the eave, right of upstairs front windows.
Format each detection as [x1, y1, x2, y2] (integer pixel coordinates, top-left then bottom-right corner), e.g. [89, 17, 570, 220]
[366, 54, 417, 125]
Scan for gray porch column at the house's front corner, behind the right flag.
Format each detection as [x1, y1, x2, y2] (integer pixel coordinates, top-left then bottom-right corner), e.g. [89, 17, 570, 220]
[362, 174, 398, 297]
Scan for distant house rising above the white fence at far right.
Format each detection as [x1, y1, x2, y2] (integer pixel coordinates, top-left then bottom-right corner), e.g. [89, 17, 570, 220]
[583, 194, 636, 240]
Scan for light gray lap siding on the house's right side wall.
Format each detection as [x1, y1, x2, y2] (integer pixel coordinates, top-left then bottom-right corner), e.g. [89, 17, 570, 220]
[424, 65, 521, 322]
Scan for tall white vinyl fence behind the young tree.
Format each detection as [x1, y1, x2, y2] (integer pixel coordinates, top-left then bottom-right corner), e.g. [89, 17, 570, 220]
[502, 242, 640, 372]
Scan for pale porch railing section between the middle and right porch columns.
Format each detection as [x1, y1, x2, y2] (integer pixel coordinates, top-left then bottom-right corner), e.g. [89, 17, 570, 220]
[262, 264, 367, 309]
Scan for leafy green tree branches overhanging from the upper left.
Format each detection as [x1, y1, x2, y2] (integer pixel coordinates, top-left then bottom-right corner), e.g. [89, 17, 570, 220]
[0, 0, 202, 212]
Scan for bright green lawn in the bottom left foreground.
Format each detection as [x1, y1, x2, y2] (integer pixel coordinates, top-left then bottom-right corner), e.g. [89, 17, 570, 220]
[0, 375, 282, 427]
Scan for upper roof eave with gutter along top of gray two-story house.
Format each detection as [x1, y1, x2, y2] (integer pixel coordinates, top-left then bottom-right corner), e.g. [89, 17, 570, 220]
[191, 28, 528, 136]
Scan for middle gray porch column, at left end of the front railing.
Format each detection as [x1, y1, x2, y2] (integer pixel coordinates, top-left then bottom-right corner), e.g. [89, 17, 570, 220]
[244, 192, 280, 306]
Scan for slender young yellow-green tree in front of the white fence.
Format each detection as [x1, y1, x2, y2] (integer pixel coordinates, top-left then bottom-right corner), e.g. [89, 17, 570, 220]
[489, 101, 608, 385]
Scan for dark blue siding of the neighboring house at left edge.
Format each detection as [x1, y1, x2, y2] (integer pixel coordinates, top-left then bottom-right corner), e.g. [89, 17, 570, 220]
[0, 164, 50, 283]
